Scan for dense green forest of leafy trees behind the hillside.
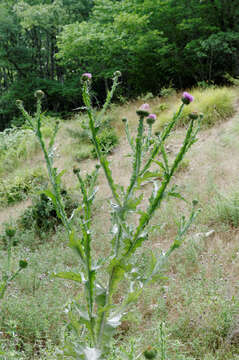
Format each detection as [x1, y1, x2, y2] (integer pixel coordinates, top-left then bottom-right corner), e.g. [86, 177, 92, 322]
[0, 0, 239, 129]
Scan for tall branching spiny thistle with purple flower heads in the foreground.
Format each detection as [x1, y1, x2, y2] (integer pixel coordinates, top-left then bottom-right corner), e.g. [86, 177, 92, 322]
[17, 72, 201, 360]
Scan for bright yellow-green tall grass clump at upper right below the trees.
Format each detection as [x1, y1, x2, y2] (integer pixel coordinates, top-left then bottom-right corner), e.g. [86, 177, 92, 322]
[156, 87, 235, 129]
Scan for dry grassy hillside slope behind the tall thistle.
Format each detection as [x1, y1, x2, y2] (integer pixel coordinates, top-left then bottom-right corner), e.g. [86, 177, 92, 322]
[0, 88, 239, 360]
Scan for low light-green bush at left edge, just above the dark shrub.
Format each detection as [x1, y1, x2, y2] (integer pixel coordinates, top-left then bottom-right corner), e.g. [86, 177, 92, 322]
[0, 168, 46, 206]
